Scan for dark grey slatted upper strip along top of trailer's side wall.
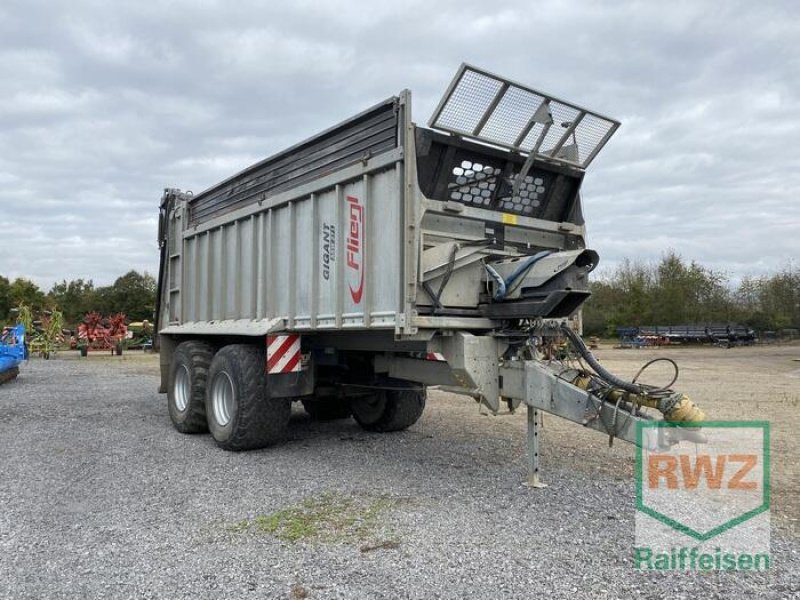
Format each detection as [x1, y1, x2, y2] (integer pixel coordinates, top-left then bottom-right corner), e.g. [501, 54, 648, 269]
[189, 97, 398, 225]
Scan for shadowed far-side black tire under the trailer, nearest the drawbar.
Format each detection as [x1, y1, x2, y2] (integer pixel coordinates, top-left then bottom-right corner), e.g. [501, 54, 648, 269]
[350, 379, 425, 433]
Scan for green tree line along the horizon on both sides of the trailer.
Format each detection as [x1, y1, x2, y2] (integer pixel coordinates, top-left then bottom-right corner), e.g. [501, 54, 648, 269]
[0, 252, 800, 336]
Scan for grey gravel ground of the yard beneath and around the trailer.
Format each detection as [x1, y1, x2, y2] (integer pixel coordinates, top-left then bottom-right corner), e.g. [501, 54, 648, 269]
[0, 353, 800, 600]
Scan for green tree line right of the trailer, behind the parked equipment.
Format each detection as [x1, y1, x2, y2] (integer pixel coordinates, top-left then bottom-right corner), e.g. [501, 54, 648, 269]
[583, 252, 800, 336]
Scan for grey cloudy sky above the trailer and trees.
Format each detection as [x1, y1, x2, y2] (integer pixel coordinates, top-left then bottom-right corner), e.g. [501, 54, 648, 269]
[0, 0, 800, 290]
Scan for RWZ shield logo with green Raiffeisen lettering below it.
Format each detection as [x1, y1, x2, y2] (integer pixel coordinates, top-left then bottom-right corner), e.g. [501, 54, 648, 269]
[633, 421, 771, 571]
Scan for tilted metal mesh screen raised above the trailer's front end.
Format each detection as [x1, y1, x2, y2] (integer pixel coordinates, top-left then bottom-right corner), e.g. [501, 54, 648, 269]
[428, 64, 619, 169]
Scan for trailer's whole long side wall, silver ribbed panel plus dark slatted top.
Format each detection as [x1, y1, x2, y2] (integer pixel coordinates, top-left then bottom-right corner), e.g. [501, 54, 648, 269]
[162, 93, 421, 334]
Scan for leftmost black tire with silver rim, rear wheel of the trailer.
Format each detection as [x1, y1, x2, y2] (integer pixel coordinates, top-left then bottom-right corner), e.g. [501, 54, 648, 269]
[167, 340, 214, 433]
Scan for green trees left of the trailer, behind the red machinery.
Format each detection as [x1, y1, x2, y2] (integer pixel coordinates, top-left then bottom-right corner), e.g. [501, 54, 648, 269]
[0, 271, 156, 329]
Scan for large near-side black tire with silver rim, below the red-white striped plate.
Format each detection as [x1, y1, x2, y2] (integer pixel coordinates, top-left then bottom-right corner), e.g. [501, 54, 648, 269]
[206, 344, 292, 451]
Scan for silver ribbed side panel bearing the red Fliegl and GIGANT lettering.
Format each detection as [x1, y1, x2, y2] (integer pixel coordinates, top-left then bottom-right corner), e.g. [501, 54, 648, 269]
[182, 160, 404, 331]
